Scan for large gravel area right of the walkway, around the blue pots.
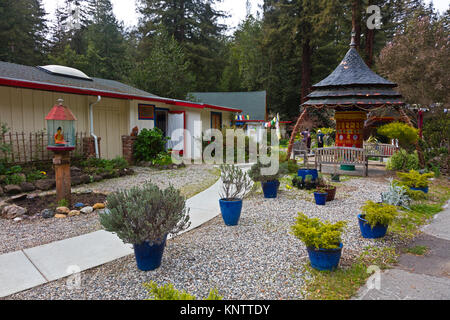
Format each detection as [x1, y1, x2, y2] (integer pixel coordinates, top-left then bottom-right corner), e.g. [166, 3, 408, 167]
[4, 178, 395, 300]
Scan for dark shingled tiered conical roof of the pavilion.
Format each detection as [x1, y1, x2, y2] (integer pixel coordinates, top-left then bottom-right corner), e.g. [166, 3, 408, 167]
[303, 38, 404, 111]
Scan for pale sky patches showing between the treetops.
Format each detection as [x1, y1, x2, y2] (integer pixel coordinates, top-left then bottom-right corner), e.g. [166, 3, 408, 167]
[43, 0, 450, 33]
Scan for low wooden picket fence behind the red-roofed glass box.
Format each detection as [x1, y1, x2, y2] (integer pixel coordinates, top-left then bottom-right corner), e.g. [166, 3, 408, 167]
[0, 131, 89, 164]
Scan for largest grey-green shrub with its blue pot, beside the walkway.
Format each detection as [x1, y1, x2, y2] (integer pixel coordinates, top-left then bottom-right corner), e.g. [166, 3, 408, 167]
[99, 183, 190, 271]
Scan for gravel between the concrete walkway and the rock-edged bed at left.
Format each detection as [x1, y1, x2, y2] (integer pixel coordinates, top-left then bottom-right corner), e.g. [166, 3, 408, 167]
[0, 165, 218, 254]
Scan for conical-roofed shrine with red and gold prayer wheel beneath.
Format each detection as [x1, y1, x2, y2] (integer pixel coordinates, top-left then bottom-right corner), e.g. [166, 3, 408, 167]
[302, 34, 404, 170]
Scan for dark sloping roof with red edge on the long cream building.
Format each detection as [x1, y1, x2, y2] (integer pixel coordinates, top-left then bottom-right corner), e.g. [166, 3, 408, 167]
[0, 61, 242, 113]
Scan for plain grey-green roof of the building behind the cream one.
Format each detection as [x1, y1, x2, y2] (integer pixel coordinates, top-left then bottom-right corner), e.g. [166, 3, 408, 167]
[189, 91, 267, 121]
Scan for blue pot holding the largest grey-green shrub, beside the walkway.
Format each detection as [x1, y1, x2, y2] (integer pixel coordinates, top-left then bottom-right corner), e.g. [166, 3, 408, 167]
[133, 235, 167, 271]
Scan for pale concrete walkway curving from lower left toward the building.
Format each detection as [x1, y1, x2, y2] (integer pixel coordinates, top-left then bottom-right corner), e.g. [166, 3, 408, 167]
[0, 165, 253, 298]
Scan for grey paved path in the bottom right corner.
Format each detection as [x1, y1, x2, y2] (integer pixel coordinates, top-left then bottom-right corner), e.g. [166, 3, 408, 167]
[355, 204, 450, 300]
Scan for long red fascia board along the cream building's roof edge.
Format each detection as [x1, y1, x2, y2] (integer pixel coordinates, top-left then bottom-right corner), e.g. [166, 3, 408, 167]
[0, 78, 242, 113]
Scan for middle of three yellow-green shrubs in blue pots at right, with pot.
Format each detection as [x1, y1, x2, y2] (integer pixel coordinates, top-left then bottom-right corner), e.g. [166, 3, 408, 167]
[358, 201, 398, 239]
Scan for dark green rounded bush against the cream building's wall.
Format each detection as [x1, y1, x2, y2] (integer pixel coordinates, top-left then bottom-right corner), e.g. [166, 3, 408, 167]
[134, 128, 169, 162]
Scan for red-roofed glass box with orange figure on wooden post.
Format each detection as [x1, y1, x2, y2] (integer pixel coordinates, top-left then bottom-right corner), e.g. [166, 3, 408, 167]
[45, 99, 77, 204]
